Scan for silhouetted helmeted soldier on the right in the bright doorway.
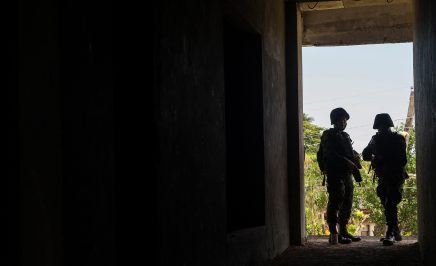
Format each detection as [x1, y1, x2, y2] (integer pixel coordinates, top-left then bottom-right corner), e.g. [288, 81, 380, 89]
[362, 114, 407, 246]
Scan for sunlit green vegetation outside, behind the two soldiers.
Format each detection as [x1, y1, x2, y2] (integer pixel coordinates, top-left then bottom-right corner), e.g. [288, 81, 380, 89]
[303, 114, 418, 236]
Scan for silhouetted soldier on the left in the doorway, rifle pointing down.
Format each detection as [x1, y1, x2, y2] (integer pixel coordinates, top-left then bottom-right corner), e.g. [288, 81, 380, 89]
[317, 108, 362, 244]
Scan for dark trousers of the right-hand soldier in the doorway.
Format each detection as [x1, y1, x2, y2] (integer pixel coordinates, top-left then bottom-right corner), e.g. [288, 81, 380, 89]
[377, 177, 404, 228]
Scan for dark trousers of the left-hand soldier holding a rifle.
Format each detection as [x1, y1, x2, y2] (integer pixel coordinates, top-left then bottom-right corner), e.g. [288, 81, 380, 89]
[327, 173, 354, 233]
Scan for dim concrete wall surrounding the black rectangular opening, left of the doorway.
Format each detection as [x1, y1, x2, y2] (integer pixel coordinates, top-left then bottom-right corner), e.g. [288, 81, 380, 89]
[153, 0, 289, 265]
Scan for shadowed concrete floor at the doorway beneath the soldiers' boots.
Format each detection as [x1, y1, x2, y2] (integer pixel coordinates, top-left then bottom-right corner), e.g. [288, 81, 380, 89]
[267, 237, 421, 266]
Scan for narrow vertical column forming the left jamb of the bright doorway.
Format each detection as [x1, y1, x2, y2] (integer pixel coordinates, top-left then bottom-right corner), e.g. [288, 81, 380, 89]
[285, 2, 305, 245]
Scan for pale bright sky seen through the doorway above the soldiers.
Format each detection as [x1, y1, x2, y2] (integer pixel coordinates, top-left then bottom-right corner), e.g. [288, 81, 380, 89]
[303, 43, 413, 153]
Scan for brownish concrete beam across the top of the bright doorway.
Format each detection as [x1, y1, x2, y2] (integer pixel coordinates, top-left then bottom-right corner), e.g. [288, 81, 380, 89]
[303, 1, 413, 46]
